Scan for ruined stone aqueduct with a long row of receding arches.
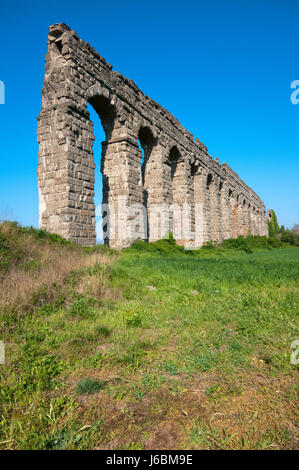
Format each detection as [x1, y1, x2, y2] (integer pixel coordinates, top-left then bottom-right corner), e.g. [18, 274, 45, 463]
[38, 24, 268, 248]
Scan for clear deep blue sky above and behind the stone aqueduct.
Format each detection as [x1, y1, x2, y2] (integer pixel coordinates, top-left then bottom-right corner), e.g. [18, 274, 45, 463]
[0, 0, 299, 227]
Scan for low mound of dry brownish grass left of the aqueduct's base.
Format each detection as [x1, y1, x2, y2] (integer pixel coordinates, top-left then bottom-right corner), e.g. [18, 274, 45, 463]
[0, 222, 112, 318]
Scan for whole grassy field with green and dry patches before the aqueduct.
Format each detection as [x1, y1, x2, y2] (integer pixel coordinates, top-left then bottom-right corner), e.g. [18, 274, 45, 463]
[0, 224, 299, 450]
